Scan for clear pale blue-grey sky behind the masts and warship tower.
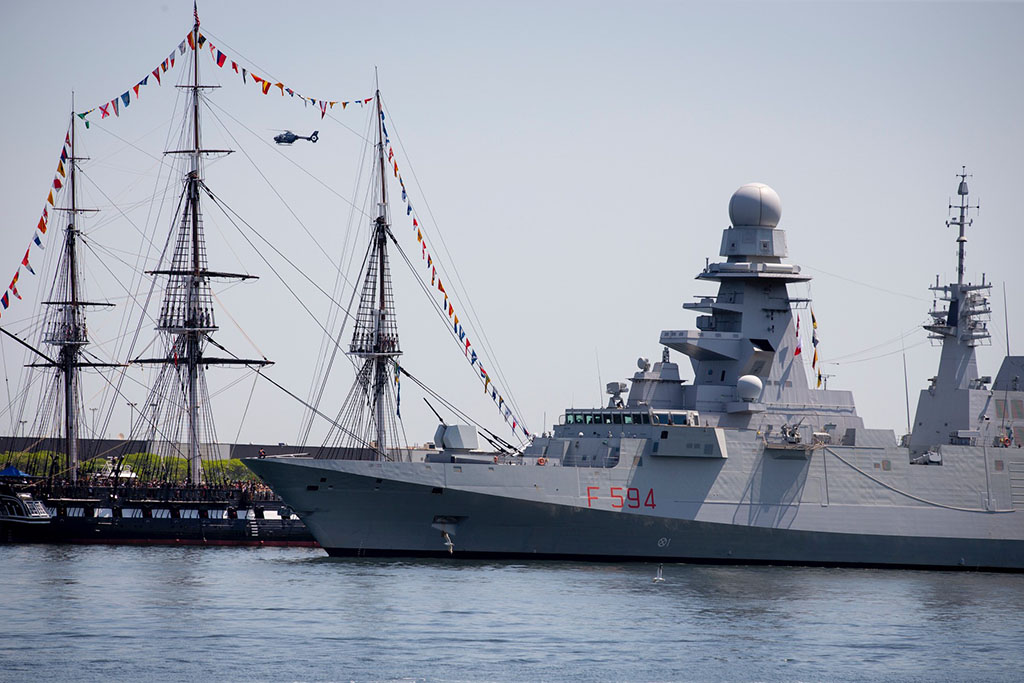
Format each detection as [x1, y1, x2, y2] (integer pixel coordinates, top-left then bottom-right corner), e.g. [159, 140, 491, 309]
[0, 1, 1024, 442]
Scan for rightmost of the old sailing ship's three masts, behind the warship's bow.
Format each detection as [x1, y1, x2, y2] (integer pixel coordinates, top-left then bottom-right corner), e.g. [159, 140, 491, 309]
[349, 90, 401, 458]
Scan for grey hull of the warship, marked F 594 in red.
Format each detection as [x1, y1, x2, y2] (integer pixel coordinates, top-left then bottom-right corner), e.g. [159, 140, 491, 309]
[247, 436, 1024, 570]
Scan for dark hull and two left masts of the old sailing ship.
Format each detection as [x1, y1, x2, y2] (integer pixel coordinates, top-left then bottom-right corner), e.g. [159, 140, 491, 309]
[0, 13, 315, 546]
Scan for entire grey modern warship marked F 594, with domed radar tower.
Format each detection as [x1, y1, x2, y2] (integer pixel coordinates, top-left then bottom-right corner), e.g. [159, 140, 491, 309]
[247, 175, 1024, 570]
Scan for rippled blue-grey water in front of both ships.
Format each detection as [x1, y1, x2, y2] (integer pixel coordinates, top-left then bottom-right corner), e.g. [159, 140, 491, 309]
[0, 546, 1024, 681]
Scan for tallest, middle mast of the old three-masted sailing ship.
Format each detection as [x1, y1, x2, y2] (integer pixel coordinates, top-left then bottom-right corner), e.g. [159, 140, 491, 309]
[136, 16, 270, 483]
